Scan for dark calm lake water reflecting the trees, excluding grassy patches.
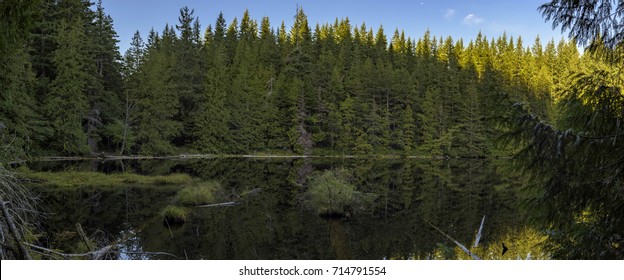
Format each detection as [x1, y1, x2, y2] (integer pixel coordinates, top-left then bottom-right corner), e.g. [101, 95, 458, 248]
[30, 158, 526, 259]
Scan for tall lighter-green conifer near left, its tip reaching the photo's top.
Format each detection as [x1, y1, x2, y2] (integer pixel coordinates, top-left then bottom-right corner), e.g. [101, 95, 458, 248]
[44, 1, 92, 155]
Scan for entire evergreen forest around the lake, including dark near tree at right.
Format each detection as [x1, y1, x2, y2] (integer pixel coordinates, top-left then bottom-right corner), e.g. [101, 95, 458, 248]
[0, 0, 624, 259]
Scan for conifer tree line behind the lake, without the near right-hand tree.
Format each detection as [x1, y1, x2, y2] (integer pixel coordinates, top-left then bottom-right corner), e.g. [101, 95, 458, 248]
[0, 0, 591, 160]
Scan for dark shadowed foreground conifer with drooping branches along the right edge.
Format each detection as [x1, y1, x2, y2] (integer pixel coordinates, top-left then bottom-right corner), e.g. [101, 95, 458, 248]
[512, 1, 624, 259]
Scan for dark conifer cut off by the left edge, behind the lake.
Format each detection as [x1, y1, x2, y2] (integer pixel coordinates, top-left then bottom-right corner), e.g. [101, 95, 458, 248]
[0, 1, 45, 160]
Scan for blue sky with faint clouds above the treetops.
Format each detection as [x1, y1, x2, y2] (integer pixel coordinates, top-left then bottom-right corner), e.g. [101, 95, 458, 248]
[103, 0, 564, 53]
